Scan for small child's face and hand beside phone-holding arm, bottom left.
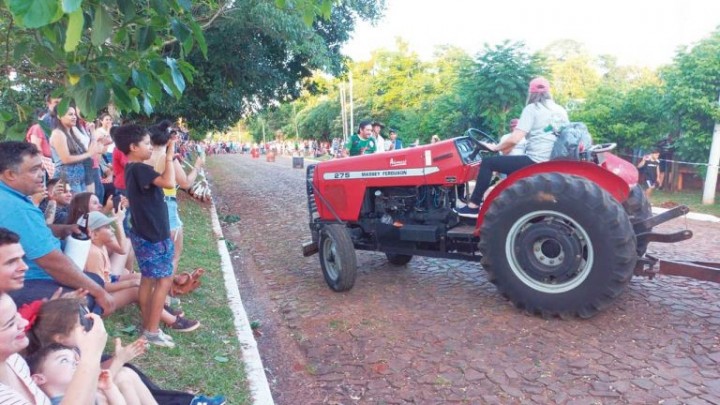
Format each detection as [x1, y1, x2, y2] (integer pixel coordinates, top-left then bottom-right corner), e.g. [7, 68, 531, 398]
[27, 343, 126, 405]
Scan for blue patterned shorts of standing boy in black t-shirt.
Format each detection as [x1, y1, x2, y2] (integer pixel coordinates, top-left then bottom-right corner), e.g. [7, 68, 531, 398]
[128, 229, 175, 279]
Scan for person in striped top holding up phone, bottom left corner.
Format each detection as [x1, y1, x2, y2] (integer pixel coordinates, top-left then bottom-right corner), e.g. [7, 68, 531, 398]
[0, 290, 107, 405]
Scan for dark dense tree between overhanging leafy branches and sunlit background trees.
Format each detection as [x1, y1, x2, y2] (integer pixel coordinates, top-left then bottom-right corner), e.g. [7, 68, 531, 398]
[152, 0, 384, 134]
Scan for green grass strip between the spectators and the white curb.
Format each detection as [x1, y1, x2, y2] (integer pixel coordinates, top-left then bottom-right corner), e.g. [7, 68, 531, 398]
[105, 194, 252, 404]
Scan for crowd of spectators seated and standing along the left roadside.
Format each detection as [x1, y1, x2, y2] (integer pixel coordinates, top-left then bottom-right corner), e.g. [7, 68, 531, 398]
[0, 96, 225, 405]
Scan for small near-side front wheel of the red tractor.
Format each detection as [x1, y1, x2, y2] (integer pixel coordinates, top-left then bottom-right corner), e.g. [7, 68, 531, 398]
[319, 224, 357, 292]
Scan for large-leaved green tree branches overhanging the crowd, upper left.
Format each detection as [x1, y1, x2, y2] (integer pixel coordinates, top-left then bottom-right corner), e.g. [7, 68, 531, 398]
[0, 0, 346, 136]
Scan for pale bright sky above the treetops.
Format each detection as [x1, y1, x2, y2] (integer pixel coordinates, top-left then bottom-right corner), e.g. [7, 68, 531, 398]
[343, 0, 720, 68]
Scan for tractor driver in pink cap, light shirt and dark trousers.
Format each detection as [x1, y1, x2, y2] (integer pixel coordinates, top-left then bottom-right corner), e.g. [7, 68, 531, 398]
[455, 77, 569, 218]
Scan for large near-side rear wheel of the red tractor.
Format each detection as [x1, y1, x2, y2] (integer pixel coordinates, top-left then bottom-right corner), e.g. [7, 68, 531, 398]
[479, 173, 637, 318]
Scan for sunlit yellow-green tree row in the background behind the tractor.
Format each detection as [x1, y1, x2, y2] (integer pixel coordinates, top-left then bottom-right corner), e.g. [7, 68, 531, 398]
[251, 30, 720, 169]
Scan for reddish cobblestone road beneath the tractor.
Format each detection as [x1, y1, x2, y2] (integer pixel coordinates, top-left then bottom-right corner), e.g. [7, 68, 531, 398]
[205, 155, 720, 404]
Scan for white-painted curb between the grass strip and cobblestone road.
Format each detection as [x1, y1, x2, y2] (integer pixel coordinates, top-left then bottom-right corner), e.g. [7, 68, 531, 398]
[211, 201, 275, 405]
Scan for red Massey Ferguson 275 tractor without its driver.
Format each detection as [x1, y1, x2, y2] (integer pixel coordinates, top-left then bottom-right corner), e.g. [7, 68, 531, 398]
[303, 130, 692, 318]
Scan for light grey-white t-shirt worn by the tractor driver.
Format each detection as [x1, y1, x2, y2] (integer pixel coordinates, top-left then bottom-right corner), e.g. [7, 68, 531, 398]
[516, 100, 569, 163]
